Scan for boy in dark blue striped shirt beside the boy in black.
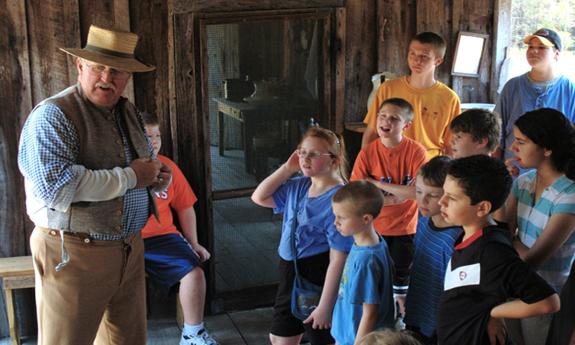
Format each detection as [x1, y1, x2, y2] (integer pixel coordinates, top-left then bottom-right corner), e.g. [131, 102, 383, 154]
[404, 156, 463, 345]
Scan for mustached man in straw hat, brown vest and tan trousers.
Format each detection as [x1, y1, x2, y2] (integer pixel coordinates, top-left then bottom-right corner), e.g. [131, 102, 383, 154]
[18, 26, 171, 345]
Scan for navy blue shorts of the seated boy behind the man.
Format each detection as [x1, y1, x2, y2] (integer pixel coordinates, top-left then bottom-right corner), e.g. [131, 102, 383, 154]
[144, 234, 201, 290]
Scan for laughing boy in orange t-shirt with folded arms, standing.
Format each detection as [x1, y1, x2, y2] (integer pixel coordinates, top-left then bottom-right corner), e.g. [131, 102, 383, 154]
[351, 98, 426, 315]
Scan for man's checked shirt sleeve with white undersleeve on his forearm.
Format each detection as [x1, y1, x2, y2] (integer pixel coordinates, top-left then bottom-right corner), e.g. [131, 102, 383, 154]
[18, 103, 137, 212]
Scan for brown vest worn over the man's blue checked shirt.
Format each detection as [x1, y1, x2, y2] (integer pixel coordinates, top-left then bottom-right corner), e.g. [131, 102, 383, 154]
[42, 84, 155, 234]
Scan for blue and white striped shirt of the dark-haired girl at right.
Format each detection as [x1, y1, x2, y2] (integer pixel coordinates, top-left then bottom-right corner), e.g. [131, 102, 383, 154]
[511, 170, 575, 291]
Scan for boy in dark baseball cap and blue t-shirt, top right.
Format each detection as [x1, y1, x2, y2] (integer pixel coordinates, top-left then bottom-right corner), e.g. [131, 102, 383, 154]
[494, 28, 575, 164]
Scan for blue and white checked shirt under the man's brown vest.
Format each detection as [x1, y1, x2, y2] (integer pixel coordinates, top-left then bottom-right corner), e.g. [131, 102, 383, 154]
[18, 103, 151, 240]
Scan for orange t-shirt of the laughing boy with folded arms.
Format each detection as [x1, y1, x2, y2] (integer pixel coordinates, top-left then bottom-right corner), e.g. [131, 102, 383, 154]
[351, 137, 427, 236]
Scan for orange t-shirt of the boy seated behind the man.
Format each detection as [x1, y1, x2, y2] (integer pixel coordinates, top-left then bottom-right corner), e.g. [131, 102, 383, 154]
[142, 155, 198, 238]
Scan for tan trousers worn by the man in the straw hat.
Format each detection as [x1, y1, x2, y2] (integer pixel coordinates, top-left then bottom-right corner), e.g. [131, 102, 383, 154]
[30, 227, 146, 345]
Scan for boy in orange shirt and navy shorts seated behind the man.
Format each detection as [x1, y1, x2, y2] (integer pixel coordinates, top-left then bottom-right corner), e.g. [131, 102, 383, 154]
[142, 113, 217, 345]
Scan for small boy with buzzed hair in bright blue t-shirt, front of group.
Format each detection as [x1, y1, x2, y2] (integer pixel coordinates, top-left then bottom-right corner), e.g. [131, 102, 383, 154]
[331, 181, 395, 345]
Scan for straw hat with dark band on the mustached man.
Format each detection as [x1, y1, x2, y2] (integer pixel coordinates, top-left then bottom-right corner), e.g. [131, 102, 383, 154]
[60, 25, 156, 72]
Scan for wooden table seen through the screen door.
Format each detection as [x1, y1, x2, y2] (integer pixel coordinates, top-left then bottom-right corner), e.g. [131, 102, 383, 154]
[213, 97, 318, 174]
